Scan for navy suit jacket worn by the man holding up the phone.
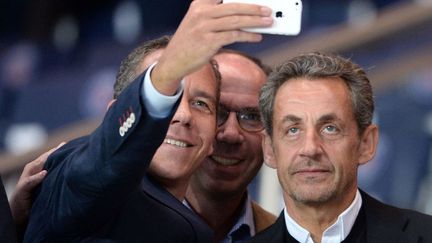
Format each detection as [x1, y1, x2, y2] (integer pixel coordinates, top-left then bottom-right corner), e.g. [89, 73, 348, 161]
[24, 73, 212, 243]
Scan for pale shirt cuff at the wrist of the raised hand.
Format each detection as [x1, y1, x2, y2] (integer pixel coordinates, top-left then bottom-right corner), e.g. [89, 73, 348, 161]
[141, 63, 184, 118]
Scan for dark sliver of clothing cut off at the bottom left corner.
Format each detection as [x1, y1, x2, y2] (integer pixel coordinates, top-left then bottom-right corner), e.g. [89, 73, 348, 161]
[0, 178, 16, 243]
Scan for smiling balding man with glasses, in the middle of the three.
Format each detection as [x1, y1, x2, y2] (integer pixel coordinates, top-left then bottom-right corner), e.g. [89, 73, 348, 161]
[186, 50, 275, 242]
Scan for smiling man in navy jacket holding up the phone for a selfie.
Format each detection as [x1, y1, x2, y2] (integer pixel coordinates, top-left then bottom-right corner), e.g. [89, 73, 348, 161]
[24, 0, 272, 243]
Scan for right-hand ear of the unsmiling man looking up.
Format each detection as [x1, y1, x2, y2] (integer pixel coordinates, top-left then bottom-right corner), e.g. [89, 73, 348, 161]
[359, 124, 378, 164]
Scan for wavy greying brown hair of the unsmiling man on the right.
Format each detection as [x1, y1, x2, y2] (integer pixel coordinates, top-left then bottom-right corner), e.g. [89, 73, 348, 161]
[259, 52, 374, 136]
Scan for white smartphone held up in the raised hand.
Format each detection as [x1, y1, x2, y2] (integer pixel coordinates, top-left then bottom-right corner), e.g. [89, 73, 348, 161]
[223, 0, 303, 35]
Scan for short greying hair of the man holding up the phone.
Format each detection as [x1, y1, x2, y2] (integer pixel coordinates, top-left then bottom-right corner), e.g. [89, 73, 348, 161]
[114, 35, 171, 99]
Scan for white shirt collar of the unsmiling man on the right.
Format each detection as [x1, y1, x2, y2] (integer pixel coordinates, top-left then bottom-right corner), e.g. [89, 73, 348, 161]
[284, 189, 362, 243]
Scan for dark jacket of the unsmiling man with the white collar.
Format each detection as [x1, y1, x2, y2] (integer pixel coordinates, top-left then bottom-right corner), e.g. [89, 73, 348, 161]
[250, 192, 432, 243]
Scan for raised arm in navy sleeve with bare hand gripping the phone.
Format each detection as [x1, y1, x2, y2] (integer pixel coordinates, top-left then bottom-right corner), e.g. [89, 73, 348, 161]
[26, 0, 271, 239]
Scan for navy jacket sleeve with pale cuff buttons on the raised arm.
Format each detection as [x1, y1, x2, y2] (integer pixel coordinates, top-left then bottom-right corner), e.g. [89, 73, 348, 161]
[25, 70, 179, 241]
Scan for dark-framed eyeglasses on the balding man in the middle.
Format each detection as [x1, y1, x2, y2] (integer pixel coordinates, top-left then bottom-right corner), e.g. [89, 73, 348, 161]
[217, 106, 264, 132]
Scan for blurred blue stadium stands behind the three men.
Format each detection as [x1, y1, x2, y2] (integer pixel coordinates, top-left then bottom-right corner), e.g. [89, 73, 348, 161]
[0, 0, 432, 214]
